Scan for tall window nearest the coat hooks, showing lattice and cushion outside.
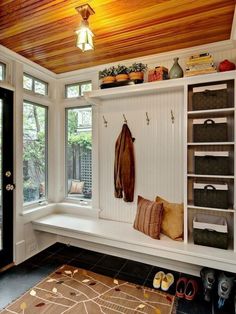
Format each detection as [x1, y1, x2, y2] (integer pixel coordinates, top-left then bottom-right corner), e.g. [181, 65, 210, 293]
[66, 107, 92, 199]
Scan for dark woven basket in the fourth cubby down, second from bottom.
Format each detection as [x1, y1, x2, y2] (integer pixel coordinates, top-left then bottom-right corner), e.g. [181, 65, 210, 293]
[193, 183, 228, 208]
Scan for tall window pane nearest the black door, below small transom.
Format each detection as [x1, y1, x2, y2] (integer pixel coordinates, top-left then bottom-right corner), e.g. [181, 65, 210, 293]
[23, 101, 48, 203]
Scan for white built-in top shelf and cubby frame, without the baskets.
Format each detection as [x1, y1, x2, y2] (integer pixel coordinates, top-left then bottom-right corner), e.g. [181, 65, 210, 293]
[86, 71, 236, 269]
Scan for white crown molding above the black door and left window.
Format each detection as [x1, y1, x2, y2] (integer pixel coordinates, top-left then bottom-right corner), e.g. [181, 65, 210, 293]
[0, 45, 57, 79]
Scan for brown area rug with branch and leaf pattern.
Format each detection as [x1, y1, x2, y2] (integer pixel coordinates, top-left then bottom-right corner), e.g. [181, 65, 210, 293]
[0, 265, 175, 314]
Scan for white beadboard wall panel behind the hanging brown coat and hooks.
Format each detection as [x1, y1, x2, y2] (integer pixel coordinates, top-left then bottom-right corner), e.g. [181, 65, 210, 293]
[99, 90, 184, 222]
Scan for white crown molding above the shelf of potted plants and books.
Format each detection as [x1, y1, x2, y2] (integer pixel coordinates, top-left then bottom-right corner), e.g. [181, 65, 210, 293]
[57, 39, 235, 79]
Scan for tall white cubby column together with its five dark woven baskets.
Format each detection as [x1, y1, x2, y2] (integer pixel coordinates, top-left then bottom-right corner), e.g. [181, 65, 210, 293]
[186, 80, 235, 250]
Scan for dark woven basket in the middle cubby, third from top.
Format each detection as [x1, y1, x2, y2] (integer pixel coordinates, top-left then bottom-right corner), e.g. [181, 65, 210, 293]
[194, 152, 231, 175]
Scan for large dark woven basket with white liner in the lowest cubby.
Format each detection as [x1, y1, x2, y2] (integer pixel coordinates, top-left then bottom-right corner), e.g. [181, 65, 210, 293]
[193, 214, 228, 249]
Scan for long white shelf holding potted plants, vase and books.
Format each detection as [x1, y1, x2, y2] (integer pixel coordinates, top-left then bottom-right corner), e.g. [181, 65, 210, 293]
[84, 70, 236, 104]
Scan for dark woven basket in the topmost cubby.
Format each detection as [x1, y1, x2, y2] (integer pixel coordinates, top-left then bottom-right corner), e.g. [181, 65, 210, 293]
[193, 88, 228, 110]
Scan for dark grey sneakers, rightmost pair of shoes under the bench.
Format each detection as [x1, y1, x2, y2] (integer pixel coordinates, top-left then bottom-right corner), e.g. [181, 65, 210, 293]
[200, 268, 235, 309]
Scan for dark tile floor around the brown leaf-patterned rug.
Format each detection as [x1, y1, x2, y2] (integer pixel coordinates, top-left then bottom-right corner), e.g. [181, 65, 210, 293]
[0, 243, 235, 314]
